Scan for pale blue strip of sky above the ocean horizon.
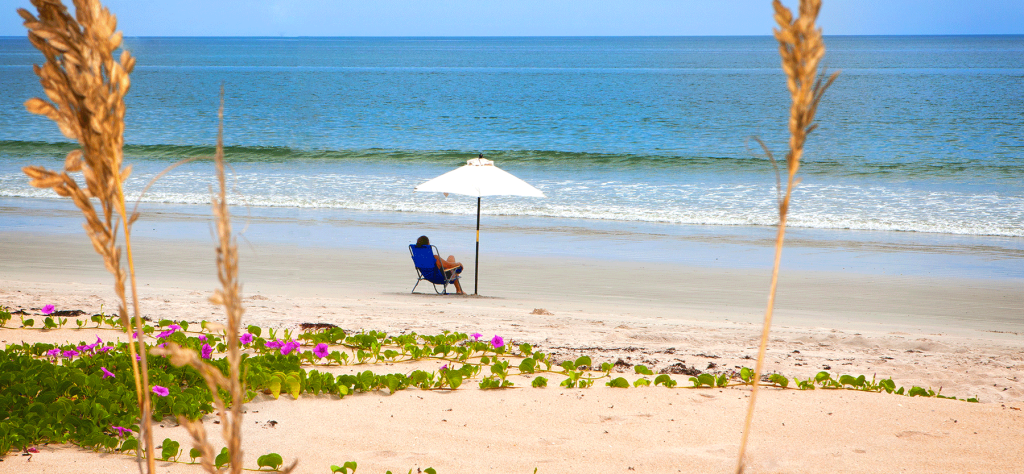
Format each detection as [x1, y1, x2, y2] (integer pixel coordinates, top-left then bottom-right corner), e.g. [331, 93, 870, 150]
[0, 0, 1024, 36]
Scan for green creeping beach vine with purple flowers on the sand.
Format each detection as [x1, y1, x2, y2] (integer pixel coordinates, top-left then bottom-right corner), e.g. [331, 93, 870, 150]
[0, 315, 978, 472]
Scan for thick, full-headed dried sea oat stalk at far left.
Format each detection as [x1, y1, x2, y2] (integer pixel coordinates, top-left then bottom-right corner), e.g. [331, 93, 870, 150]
[17, 0, 155, 472]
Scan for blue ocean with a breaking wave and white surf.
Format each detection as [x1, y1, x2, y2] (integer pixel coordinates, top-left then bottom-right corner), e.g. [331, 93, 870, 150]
[0, 36, 1024, 278]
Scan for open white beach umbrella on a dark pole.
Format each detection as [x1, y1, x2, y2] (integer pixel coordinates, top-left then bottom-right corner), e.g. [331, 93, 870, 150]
[416, 155, 544, 295]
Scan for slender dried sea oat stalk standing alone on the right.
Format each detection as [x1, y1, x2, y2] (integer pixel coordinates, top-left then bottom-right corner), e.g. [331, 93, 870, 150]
[736, 0, 838, 474]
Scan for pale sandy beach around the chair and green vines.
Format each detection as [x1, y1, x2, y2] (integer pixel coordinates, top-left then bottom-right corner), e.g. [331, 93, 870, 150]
[0, 228, 1024, 473]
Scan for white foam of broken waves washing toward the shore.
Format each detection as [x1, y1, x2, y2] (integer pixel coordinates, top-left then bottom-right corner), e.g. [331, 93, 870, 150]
[0, 168, 1024, 236]
